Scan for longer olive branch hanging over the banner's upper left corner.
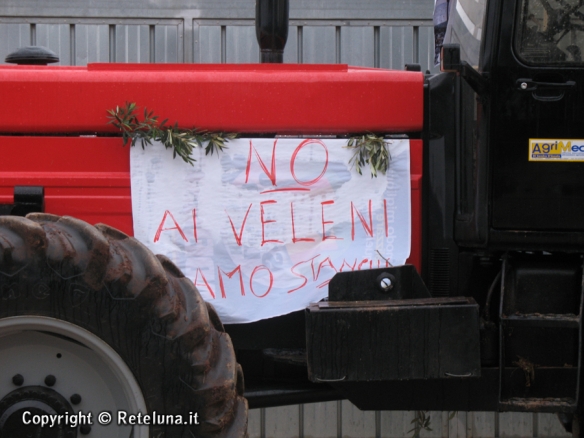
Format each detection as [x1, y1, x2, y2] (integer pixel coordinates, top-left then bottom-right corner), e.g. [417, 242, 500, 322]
[108, 102, 237, 165]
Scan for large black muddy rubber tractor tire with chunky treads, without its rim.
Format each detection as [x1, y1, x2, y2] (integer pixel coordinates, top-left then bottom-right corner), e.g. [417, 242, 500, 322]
[0, 213, 247, 438]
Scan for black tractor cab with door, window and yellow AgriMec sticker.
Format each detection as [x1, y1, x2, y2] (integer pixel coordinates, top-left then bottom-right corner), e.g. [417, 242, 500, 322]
[306, 0, 584, 428]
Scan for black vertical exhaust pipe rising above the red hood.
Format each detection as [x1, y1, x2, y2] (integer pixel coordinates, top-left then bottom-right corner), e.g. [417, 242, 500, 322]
[256, 0, 289, 64]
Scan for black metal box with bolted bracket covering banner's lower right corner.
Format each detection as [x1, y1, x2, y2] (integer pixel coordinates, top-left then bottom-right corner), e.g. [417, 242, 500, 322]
[306, 265, 481, 383]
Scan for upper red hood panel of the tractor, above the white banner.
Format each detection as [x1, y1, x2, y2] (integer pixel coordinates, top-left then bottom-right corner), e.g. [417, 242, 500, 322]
[0, 64, 424, 134]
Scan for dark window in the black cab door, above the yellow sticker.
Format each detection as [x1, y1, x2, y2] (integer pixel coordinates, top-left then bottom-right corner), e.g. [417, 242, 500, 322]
[515, 0, 584, 65]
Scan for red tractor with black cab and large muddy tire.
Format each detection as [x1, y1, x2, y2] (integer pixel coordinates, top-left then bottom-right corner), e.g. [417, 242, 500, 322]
[0, 0, 584, 437]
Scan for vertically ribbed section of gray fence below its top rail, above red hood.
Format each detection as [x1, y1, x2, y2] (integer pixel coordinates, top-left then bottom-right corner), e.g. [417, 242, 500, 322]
[0, 17, 434, 69]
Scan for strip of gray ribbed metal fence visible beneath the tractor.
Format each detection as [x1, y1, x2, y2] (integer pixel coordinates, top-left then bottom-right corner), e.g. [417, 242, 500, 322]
[249, 404, 571, 438]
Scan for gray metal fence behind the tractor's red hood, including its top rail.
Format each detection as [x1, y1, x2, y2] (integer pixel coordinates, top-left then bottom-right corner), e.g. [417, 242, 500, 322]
[0, 0, 434, 69]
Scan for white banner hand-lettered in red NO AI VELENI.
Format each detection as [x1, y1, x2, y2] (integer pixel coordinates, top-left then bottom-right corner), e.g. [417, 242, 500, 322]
[131, 138, 411, 323]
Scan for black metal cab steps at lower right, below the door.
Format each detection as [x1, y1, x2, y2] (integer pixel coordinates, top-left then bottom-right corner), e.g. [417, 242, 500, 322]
[499, 254, 584, 413]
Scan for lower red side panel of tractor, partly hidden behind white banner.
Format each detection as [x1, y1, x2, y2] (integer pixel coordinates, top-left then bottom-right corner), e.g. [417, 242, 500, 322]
[0, 136, 422, 270]
